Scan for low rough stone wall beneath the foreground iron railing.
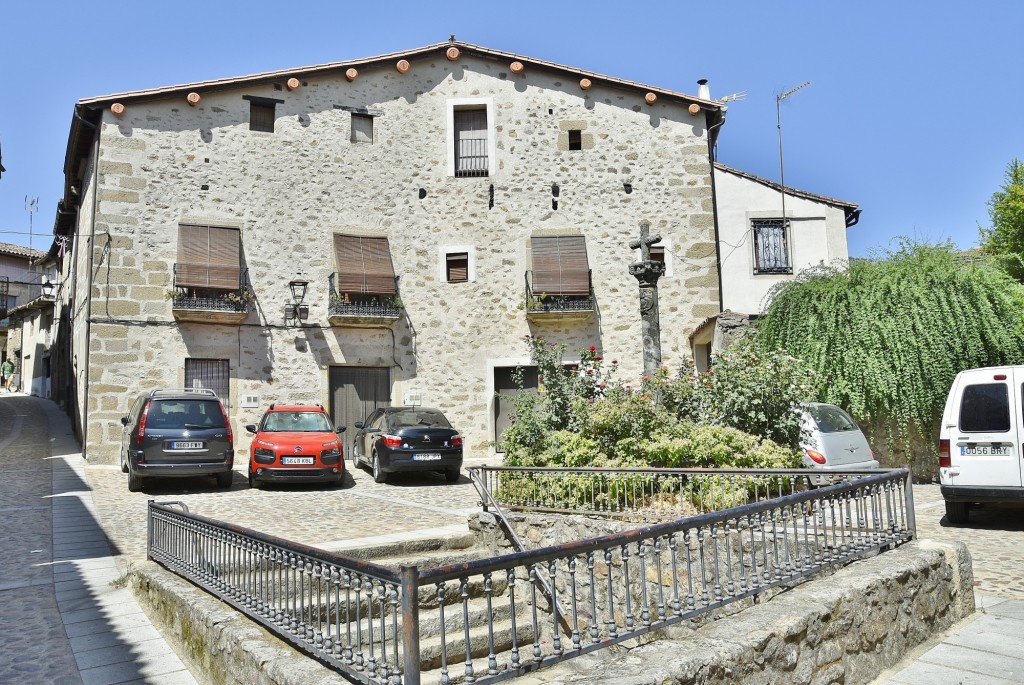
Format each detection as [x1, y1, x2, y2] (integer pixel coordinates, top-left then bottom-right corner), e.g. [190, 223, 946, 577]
[132, 541, 974, 685]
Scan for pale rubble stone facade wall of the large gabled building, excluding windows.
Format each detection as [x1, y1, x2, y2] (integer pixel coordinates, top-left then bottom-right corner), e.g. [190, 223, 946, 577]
[77, 56, 719, 463]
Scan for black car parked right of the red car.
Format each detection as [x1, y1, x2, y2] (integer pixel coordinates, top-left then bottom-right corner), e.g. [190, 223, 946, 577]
[351, 406, 462, 483]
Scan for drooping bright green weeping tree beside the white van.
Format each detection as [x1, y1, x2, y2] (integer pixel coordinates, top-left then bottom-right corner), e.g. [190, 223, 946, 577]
[754, 241, 1024, 455]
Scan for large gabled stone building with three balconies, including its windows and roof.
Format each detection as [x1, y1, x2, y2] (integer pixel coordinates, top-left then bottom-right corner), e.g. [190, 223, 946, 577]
[54, 40, 724, 463]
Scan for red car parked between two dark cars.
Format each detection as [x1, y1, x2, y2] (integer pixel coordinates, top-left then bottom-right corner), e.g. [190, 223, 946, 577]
[246, 403, 345, 488]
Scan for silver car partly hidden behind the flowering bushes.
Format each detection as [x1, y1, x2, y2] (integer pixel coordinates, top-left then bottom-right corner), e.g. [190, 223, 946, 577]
[800, 402, 879, 485]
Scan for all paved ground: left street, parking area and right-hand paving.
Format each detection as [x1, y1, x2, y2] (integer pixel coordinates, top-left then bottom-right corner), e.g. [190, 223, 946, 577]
[6, 393, 1024, 685]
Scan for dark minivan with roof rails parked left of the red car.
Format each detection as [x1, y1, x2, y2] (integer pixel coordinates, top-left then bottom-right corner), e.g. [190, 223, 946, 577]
[121, 388, 234, 493]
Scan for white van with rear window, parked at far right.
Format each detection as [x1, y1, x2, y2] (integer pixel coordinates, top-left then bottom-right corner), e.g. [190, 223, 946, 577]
[939, 367, 1024, 523]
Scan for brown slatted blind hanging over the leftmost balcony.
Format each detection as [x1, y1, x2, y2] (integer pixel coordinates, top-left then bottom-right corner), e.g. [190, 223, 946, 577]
[174, 223, 242, 290]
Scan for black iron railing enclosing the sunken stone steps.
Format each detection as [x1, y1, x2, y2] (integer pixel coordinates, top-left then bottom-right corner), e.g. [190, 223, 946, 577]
[148, 467, 914, 685]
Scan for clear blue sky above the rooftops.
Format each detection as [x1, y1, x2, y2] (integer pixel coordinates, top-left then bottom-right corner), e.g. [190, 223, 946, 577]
[0, 0, 1024, 256]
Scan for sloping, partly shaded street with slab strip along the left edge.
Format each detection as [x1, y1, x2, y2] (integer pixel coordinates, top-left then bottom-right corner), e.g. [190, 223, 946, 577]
[0, 393, 196, 685]
